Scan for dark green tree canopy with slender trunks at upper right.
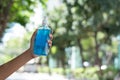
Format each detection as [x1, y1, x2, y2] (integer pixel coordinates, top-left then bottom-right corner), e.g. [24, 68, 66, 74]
[64, 0, 120, 66]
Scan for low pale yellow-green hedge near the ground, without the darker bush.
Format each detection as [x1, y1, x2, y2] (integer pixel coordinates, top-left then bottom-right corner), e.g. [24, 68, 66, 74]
[38, 67, 99, 80]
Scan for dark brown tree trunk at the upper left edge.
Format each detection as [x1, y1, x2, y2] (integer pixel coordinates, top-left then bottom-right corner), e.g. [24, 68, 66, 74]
[0, 0, 13, 42]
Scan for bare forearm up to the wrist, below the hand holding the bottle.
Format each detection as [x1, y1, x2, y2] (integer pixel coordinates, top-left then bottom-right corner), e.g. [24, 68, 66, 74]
[0, 50, 33, 80]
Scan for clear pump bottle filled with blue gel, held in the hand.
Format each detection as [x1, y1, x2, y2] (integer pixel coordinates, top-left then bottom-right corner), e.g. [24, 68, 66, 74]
[33, 18, 51, 56]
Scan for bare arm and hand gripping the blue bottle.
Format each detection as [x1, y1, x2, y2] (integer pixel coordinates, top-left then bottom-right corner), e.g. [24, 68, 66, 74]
[0, 30, 53, 80]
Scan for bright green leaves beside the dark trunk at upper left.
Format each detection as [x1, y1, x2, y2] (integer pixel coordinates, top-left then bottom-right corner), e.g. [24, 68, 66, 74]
[10, 0, 37, 25]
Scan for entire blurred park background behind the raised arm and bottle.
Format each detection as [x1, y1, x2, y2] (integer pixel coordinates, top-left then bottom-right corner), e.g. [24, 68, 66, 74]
[0, 0, 120, 80]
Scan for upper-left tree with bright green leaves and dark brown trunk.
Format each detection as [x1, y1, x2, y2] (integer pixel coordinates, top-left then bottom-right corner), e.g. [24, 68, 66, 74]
[0, 0, 48, 42]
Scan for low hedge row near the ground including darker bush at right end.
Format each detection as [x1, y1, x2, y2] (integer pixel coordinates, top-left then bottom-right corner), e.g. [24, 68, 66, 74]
[38, 66, 118, 80]
